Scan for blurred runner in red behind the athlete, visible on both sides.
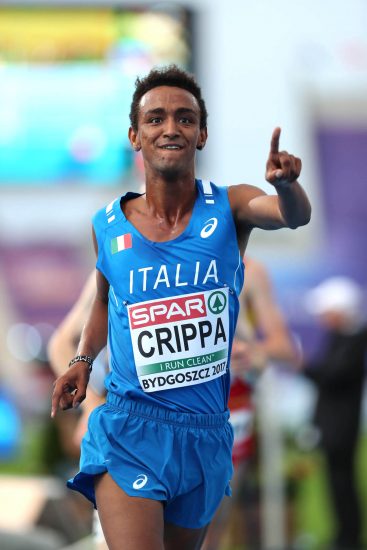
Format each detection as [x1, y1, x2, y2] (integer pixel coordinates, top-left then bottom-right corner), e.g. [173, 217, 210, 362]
[48, 256, 299, 550]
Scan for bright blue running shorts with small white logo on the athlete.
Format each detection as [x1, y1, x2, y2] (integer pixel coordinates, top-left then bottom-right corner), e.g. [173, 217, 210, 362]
[68, 393, 233, 529]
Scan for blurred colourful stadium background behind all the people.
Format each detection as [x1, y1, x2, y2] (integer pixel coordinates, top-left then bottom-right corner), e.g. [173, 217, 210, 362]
[0, 0, 367, 550]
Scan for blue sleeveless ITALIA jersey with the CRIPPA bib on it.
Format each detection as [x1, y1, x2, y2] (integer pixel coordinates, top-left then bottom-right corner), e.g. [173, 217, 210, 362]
[93, 180, 244, 414]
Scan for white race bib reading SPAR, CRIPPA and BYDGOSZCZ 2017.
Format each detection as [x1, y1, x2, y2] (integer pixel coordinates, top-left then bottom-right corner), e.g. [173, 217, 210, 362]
[127, 288, 229, 392]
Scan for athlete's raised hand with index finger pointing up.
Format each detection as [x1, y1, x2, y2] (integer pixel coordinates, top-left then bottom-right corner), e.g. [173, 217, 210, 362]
[265, 128, 302, 187]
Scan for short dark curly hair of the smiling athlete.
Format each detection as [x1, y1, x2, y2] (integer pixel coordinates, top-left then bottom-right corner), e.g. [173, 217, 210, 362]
[129, 65, 208, 131]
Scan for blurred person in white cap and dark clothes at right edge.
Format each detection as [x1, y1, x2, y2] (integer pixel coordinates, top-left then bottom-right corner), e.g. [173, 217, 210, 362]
[303, 277, 367, 550]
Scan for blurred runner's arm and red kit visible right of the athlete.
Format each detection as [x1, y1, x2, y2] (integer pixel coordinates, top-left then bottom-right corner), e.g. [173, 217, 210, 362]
[203, 256, 300, 550]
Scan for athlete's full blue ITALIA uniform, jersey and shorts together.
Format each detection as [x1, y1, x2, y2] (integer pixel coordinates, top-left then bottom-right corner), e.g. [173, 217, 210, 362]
[69, 180, 244, 528]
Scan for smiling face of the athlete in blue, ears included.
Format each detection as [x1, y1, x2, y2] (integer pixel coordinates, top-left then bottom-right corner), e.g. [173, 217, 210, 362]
[129, 86, 207, 178]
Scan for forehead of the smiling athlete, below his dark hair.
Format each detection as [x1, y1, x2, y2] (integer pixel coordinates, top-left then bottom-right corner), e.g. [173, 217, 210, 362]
[139, 86, 200, 113]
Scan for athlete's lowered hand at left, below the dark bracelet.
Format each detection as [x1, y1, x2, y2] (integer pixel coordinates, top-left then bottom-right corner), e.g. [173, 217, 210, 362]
[51, 361, 90, 418]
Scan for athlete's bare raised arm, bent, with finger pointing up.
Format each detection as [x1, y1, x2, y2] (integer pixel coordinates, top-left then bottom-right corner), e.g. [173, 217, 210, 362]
[228, 128, 311, 242]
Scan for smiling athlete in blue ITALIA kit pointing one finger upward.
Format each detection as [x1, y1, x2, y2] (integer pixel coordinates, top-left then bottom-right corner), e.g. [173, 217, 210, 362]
[51, 66, 311, 550]
